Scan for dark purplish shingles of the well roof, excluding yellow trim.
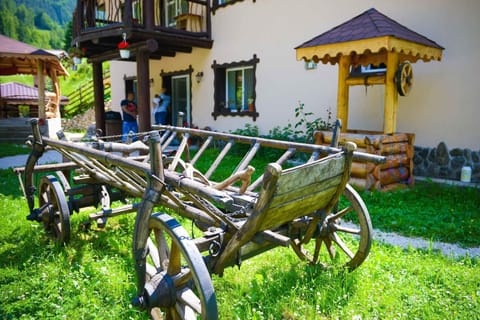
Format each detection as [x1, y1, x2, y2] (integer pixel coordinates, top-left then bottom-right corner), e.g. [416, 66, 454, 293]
[295, 8, 444, 49]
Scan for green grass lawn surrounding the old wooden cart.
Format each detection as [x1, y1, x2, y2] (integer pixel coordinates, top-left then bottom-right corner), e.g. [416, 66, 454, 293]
[0, 149, 480, 319]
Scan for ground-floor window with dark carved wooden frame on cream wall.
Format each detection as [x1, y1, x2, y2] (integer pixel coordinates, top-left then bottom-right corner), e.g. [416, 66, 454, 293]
[212, 55, 260, 120]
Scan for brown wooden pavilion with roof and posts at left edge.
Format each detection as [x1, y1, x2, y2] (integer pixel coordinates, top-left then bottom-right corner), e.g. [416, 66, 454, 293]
[0, 35, 68, 119]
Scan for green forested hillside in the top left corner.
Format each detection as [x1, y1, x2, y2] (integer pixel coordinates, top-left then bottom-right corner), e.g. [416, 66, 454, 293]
[0, 0, 76, 49]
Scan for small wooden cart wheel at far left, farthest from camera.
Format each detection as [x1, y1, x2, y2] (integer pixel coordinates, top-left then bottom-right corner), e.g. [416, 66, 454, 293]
[38, 175, 70, 244]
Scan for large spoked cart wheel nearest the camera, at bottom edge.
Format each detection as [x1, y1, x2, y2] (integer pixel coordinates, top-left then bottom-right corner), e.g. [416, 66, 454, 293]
[135, 213, 218, 319]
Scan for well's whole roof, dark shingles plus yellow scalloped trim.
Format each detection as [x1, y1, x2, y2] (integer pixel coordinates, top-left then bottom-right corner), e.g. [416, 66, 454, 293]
[295, 8, 444, 65]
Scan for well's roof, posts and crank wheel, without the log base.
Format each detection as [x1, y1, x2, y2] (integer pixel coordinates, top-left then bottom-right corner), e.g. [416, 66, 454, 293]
[295, 8, 444, 134]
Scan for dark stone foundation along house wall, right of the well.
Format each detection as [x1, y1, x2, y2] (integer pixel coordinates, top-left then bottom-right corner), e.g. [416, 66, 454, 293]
[413, 142, 480, 183]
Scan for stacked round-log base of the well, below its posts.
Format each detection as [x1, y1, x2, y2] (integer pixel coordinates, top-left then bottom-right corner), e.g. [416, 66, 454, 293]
[315, 131, 415, 191]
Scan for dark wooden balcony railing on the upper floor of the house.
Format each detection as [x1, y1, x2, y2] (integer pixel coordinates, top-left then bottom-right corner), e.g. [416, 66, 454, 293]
[73, 0, 211, 39]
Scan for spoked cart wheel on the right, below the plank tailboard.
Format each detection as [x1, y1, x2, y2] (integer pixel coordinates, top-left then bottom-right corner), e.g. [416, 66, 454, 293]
[293, 184, 372, 271]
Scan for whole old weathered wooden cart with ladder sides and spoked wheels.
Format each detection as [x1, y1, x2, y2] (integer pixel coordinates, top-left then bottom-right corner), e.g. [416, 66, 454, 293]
[17, 121, 384, 319]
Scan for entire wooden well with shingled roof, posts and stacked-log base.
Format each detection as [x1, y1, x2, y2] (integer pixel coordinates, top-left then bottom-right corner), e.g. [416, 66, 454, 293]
[295, 8, 444, 189]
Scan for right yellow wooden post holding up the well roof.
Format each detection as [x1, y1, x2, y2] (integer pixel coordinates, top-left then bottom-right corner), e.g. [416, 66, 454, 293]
[383, 51, 399, 134]
